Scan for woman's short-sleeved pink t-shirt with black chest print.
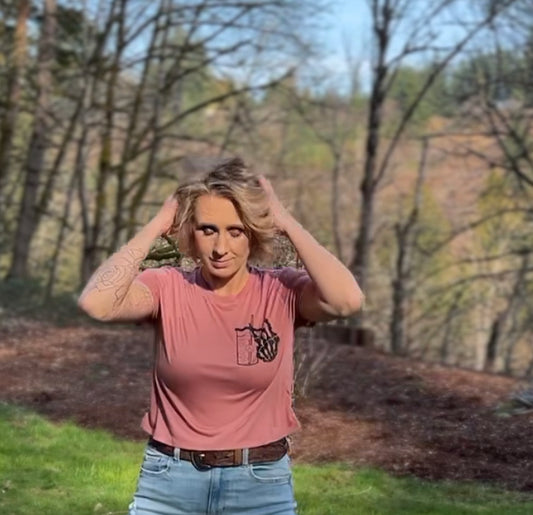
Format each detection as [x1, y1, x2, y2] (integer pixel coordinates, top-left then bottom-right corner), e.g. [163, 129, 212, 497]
[137, 267, 310, 450]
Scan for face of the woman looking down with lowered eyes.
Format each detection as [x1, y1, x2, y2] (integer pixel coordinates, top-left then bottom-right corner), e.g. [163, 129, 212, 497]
[194, 194, 250, 281]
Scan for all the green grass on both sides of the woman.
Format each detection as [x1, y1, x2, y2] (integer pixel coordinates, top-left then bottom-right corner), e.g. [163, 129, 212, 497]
[0, 404, 533, 515]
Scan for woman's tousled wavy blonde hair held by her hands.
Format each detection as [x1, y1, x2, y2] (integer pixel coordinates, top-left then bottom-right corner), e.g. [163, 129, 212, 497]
[172, 157, 276, 262]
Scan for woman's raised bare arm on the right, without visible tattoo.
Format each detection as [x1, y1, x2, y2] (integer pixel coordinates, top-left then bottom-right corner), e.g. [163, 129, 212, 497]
[260, 177, 364, 322]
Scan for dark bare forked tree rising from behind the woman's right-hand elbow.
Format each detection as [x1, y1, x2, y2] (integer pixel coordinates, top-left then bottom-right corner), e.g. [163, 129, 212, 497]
[350, 0, 514, 298]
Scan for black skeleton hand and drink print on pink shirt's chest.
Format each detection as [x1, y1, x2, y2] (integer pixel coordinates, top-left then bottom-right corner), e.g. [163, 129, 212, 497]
[235, 315, 279, 365]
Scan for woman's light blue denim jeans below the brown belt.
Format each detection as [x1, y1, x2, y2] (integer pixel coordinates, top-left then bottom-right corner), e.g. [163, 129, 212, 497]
[129, 445, 296, 515]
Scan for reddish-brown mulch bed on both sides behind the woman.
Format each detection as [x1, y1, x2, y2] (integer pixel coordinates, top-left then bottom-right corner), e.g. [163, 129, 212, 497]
[0, 319, 533, 490]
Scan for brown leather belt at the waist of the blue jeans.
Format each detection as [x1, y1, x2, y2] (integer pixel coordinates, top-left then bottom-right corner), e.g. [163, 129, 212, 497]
[148, 438, 289, 470]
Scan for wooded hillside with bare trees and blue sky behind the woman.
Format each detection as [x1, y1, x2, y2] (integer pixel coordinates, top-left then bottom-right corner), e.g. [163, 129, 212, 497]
[0, 0, 533, 376]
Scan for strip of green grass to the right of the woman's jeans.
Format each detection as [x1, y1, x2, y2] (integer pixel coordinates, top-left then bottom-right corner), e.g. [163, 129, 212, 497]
[294, 464, 533, 515]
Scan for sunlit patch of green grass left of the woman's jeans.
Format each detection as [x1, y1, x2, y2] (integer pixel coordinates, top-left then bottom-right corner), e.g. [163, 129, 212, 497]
[0, 405, 139, 515]
